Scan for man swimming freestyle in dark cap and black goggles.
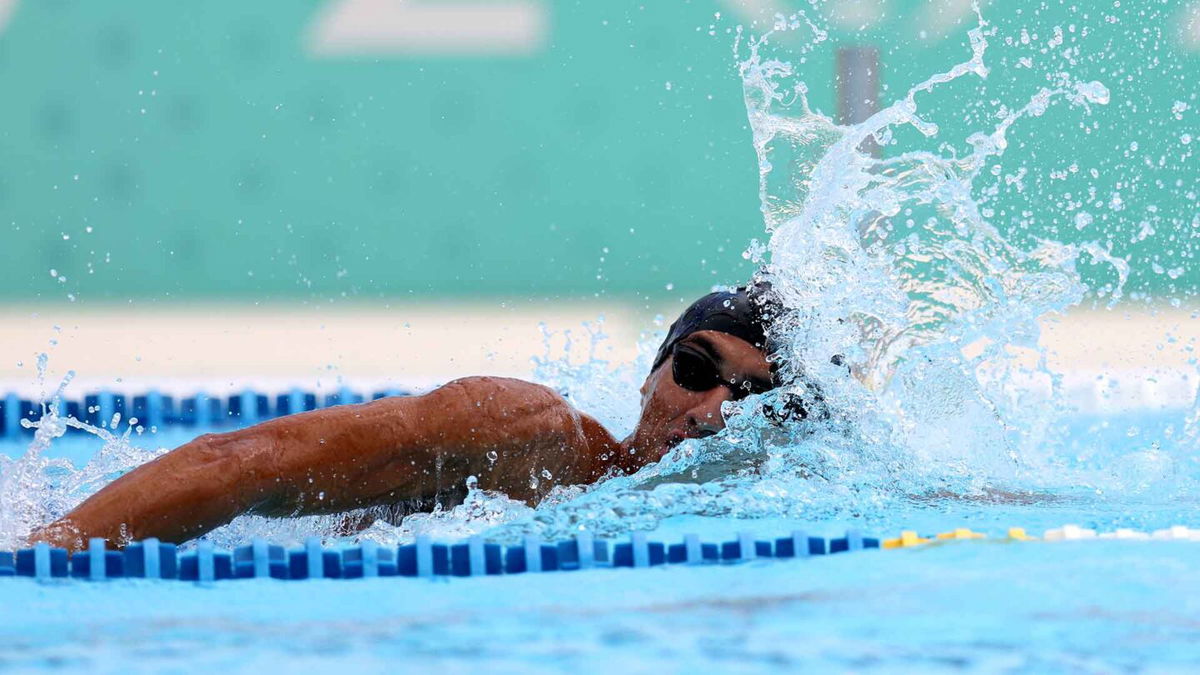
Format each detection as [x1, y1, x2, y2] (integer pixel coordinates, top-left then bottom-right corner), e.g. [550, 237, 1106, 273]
[30, 285, 778, 550]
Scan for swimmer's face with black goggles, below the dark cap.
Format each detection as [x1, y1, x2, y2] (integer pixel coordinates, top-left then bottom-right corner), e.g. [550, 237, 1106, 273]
[628, 330, 772, 468]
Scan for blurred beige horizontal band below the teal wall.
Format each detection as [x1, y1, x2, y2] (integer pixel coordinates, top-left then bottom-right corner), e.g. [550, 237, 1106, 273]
[0, 301, 1200, 403]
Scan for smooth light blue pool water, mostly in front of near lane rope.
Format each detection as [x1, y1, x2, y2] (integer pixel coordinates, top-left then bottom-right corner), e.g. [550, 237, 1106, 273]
[0, 401, 1200, 673]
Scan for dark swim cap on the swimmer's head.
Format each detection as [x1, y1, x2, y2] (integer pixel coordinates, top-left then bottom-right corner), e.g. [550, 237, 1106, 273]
[650, 281, 780, 371]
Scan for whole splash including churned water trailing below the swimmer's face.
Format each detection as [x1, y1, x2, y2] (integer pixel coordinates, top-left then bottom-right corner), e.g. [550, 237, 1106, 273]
[468, 6, 1152, 537]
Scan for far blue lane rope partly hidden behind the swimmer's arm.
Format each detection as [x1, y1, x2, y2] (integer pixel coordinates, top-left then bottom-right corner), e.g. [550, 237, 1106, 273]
[0, 389, 412, 441]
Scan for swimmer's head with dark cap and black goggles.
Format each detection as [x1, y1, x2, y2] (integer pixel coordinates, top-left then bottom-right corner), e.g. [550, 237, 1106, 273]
[628, 282, 780, 465]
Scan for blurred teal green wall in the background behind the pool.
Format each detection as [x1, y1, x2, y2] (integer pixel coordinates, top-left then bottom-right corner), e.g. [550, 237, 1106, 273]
[0, 0, 1200, 301]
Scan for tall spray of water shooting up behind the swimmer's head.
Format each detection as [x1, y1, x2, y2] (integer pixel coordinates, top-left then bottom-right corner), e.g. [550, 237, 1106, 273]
[740, 9, 1128, 476]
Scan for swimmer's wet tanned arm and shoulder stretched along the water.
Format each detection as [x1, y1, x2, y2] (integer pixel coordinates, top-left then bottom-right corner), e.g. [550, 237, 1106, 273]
[30, 377, 605, 549]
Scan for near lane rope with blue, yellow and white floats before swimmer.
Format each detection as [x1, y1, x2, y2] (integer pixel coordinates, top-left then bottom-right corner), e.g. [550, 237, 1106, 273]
[0, 525, 1200, 585]
